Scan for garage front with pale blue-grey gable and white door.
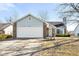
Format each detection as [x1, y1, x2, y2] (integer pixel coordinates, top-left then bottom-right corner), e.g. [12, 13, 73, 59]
[13, 15, 44, 38]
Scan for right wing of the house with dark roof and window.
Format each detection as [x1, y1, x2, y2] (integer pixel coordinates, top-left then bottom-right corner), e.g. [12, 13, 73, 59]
[48, 22, 65, 34]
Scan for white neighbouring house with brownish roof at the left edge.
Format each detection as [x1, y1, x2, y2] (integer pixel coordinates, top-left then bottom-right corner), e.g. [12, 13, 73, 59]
[0, 23, 13, 35]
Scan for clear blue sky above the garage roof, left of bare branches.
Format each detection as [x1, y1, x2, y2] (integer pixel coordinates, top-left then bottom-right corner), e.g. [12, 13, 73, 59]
[0, 3, 60, 22]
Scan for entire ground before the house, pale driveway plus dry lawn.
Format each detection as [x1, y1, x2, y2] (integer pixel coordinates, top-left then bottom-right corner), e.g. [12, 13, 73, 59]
[0, 37, 79, 56]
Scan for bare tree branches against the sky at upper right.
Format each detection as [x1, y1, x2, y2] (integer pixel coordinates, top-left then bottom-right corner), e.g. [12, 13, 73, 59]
[60, 3, 79, 17]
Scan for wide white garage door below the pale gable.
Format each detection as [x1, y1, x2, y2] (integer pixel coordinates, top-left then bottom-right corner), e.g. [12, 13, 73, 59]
[17, 27, 43, 38]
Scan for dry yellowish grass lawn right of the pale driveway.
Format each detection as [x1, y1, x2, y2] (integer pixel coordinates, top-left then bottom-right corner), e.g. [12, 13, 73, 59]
[32, 38, 79, 56]
